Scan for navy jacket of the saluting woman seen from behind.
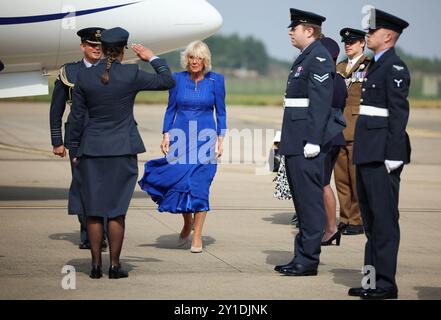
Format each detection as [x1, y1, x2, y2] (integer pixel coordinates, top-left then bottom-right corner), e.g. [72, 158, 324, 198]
[70, 59, 175, 157]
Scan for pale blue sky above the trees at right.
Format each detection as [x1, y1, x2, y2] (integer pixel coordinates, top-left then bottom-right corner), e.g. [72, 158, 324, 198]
[208, 0, 441, 60]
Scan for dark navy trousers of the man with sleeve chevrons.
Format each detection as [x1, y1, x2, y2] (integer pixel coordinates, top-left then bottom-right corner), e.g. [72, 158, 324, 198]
[285, 152, 326, 268]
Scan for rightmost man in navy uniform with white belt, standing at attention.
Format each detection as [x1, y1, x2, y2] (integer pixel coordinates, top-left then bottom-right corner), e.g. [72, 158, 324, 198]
[348, 9, 410, 299]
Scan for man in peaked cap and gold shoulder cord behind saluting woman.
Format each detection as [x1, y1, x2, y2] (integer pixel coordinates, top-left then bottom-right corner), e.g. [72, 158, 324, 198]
[50, 27, 107, 249]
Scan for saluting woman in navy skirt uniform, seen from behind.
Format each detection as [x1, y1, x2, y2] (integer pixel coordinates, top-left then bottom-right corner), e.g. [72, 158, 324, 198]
[70, 27, 175, 279]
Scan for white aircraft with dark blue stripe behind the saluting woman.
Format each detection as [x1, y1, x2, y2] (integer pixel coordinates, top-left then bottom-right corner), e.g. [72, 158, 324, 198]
[0, 0, 222, 98]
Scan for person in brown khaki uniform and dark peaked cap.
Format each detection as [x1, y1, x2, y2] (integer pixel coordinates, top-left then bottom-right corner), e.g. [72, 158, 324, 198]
[334, 28, 371, 235]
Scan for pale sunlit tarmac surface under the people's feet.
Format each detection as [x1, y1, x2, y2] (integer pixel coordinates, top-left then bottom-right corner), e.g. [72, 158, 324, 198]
[0, 101, 441, 300]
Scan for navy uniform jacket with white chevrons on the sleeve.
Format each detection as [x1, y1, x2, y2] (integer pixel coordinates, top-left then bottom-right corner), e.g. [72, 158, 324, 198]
[279, 40, 344, 155]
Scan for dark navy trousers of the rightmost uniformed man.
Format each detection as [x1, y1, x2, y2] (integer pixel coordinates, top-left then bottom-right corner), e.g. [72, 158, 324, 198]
[356, 162, 403, 290]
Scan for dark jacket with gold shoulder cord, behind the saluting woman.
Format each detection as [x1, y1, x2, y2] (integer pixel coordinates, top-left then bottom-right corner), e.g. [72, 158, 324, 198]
[49, 60, 87, 149]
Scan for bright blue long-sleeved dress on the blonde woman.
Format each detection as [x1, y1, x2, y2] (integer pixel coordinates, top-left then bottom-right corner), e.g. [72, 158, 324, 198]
[138, 71, 226, 213]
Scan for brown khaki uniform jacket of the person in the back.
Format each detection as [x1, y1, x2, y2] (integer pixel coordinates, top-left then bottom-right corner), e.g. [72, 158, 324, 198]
[337, 55, 371, 142]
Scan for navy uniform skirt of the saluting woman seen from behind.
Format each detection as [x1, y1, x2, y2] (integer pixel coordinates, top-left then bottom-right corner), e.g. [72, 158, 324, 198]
[70, 155, 138, 218]
